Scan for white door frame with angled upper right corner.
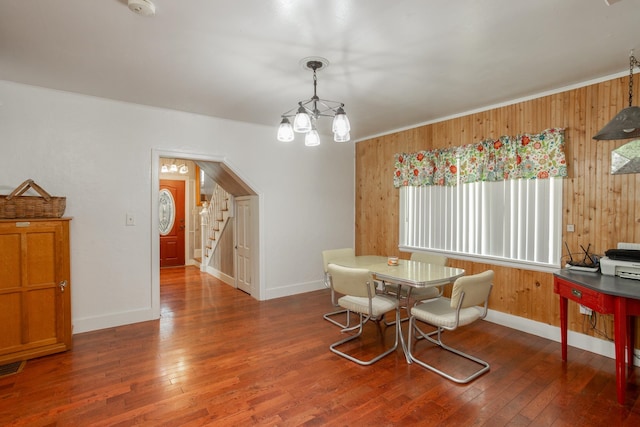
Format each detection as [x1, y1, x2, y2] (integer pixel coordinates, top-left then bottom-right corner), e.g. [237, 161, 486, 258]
[150, 148, 266, 318]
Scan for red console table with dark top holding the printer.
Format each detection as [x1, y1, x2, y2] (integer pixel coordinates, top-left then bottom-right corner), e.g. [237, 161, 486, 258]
[553, 270, 640, 404]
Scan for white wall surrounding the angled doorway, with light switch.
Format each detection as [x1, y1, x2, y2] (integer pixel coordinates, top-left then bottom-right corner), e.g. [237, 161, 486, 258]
[0, 80, 355, 333]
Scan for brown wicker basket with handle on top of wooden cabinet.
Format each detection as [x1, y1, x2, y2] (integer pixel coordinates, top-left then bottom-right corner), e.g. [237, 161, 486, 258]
[0, 179, 67, 219]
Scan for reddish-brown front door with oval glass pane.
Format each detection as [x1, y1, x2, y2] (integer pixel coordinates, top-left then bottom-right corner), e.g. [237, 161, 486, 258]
[158, 179, 185, 267]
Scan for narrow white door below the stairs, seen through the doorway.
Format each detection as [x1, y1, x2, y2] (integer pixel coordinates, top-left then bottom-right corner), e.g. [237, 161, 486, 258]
[235, 198, 253, 295]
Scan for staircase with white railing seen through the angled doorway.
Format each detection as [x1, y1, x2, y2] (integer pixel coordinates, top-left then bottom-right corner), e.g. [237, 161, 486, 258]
[200, 184, 233, 271]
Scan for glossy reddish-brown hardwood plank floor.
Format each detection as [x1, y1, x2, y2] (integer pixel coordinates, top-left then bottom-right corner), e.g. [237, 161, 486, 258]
[0, 267, 640, 427]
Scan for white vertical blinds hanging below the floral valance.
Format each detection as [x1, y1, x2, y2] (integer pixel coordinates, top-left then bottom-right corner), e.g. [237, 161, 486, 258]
[400, 178, 562, 270]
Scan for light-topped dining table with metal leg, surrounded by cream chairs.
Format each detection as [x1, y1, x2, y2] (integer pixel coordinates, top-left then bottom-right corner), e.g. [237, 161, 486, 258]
[331, 255, 465, 363]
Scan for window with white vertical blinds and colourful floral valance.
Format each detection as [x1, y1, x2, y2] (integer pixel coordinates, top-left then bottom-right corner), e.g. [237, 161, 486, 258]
[394, 129, 567, 270]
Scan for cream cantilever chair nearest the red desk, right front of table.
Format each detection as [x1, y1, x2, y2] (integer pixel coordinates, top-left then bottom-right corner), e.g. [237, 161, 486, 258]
[407, 270, 494, 384]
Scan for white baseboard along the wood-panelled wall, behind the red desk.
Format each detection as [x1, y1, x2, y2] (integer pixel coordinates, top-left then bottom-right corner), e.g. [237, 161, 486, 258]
[485, 310, 640, 366]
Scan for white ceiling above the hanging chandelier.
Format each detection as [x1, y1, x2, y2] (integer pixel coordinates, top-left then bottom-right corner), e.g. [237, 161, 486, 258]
[0, 0, 640, 140]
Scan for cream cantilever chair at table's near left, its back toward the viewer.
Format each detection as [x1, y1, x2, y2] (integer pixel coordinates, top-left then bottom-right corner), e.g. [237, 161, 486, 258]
[328, 264, 400, 366]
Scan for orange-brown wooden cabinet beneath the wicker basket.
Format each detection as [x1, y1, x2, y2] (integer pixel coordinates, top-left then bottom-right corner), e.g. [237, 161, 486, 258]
[0, 218, 72, 364]
